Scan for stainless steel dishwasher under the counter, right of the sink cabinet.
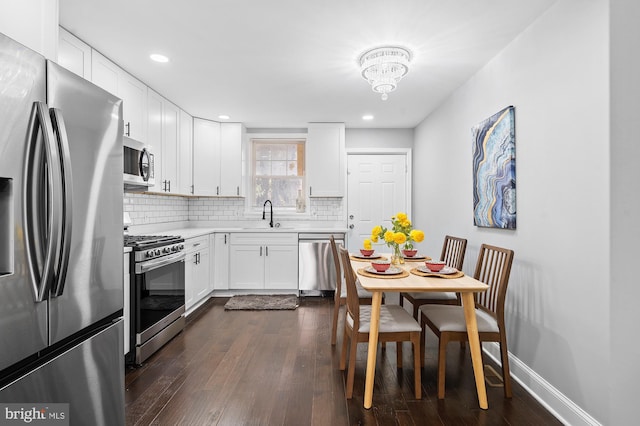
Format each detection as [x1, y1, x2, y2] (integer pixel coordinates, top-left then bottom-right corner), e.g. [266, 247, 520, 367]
[298, 232, 345, 296]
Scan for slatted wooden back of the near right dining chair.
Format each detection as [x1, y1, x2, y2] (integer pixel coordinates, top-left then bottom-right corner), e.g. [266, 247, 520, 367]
[474, 244, 513, 323]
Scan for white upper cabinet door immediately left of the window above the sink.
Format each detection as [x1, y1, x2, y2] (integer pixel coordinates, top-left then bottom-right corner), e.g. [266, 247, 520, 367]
[219, 123, 245, 197]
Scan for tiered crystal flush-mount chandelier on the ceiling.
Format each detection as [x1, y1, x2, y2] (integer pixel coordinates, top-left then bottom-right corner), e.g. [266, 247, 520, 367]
[358, 46, 411, 101]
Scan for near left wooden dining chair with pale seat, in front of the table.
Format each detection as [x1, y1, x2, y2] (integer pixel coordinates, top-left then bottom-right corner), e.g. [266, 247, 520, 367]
[340, 248, 422, 399]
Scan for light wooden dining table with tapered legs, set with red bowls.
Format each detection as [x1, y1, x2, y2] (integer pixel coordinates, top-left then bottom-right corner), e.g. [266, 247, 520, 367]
[351, 255, 489, 410]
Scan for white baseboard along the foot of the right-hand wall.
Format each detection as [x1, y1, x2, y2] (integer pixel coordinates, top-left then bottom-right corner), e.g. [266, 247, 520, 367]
[482, 343, 602, 426]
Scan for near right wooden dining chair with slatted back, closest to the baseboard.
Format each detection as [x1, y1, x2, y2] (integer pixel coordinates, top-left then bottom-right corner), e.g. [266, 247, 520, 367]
[420, 244, 513, 399]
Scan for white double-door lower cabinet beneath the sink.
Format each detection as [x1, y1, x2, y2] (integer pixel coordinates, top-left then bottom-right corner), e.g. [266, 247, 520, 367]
[229, 232, 298, 291]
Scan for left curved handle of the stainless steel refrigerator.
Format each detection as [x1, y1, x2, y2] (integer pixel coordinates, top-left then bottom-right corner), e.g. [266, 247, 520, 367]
[22, 102, 62, 302]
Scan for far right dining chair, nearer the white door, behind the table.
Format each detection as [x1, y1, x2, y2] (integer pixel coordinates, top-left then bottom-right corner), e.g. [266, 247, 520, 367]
[400, 235, 467, 320]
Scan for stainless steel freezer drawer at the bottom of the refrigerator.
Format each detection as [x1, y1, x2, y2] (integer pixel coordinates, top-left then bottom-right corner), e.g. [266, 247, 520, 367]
[0, 319, 125, 426]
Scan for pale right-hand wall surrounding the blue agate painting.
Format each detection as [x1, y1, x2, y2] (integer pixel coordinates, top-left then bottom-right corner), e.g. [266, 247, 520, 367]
[414, 0, 611, 423]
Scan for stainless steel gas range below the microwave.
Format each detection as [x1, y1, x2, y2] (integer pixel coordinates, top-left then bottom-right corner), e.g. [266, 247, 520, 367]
[124, 235, 185, 364]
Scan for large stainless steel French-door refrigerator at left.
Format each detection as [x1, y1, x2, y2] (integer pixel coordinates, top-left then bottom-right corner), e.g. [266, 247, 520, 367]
[0, 34, 124, 426]
